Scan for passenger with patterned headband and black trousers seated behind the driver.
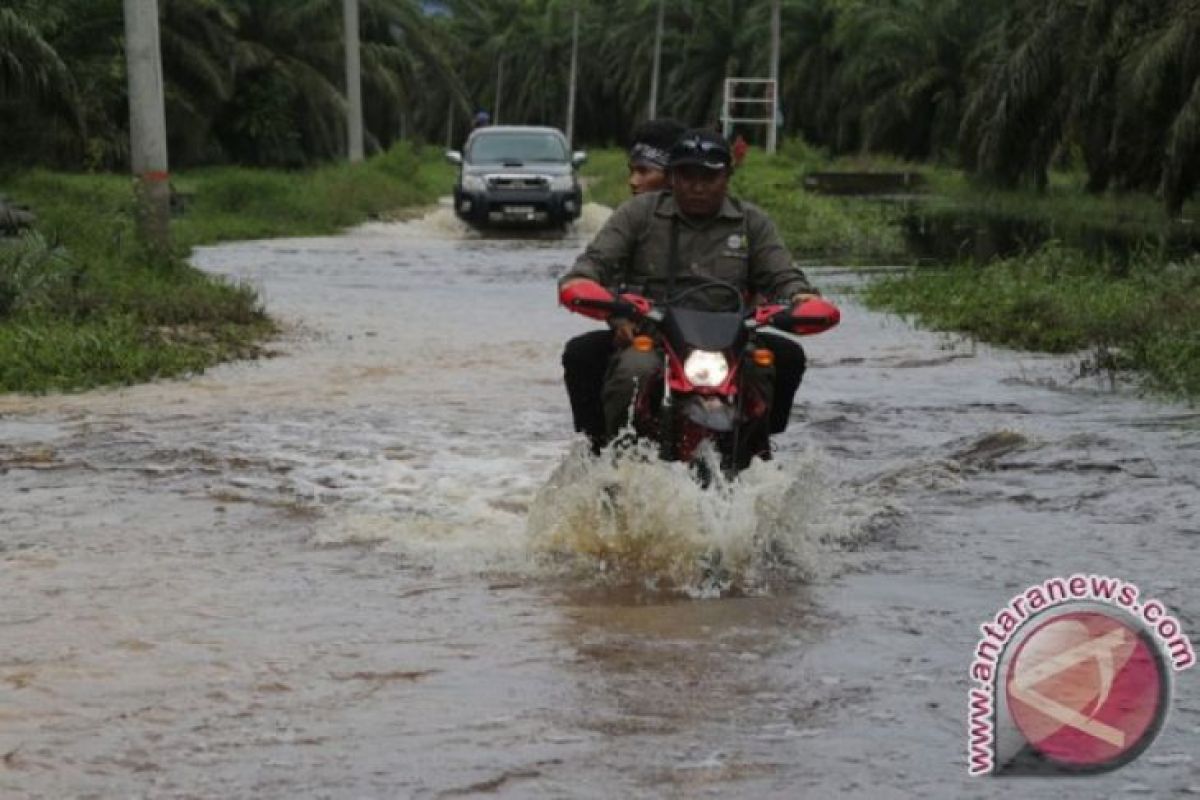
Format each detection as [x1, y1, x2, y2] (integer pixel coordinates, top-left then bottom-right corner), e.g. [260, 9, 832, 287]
[563, 119, 686, 452]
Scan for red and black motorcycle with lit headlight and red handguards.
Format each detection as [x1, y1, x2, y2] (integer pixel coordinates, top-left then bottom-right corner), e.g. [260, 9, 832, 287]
[559, 281, 841, 475]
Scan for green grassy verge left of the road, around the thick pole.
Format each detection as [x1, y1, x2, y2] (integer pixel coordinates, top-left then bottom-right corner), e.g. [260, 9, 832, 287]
[0, 146, 451, 392]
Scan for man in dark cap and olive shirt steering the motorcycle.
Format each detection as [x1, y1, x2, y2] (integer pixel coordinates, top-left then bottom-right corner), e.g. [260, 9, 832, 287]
[559, 130, 817, 447]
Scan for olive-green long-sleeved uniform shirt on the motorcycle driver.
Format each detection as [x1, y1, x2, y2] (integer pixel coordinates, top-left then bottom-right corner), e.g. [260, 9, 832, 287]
[562, 192, 816, 308]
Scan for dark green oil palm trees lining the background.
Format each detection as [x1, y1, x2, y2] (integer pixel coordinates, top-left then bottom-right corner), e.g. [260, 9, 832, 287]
[0, 0, 1200, 211]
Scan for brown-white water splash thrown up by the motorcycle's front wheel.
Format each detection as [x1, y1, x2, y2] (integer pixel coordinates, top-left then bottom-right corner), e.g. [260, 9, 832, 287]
[528, 445, 860, 597]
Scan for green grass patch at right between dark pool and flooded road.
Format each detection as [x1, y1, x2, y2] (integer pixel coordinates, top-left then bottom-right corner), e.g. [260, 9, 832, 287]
[865, 243, 1200, 398]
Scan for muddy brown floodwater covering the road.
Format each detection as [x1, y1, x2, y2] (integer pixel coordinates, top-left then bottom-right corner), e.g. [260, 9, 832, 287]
[0, 210, 1200, 800]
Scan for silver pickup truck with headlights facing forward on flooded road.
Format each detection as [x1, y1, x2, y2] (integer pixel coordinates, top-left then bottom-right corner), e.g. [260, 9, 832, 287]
[446, 125, 587, 227]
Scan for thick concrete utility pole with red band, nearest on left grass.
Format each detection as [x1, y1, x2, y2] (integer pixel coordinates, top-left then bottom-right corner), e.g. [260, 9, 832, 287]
[125, 0, 170, 254]
